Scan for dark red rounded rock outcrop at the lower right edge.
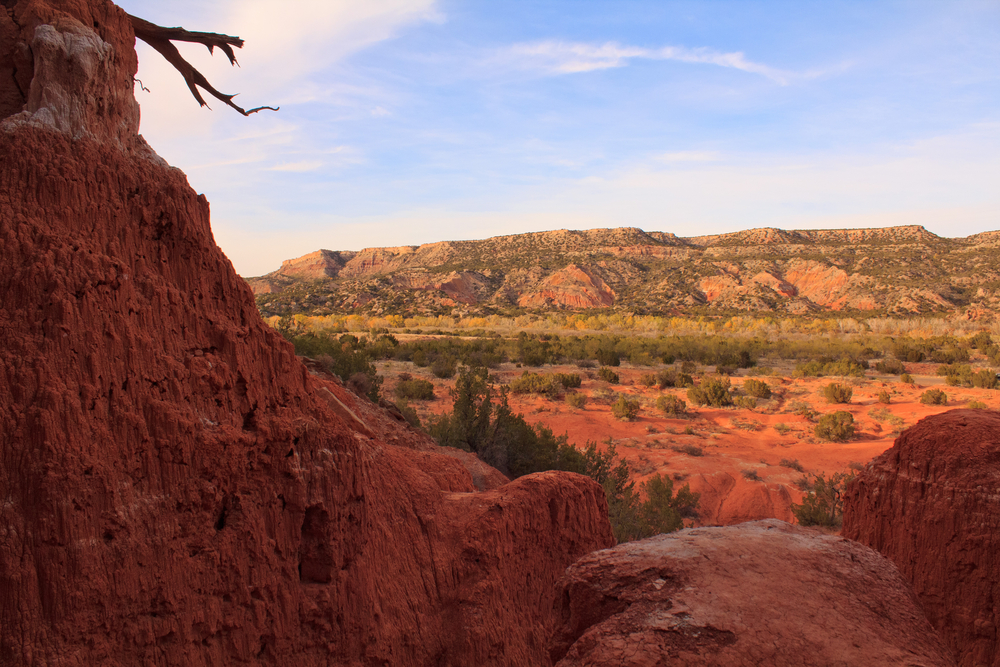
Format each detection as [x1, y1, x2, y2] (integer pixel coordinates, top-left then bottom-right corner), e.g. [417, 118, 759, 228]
[843, 410, 1000, 667]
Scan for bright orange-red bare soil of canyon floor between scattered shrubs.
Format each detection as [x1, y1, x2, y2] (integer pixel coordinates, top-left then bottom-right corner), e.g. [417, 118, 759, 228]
[379, 361, 988, 525]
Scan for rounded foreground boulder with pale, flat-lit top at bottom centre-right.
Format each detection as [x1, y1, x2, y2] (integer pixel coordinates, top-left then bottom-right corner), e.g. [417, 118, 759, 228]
[552, 519, 954, 667]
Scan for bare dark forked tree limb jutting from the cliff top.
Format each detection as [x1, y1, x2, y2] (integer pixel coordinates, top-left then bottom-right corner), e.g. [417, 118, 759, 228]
[129, 14, 280, 116]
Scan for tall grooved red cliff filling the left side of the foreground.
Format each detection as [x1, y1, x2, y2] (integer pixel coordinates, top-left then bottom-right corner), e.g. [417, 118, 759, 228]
[0, 0, 613, 667]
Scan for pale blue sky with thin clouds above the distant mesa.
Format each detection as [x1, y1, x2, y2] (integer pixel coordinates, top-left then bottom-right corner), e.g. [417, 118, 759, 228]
[120, 0, 1000, 276]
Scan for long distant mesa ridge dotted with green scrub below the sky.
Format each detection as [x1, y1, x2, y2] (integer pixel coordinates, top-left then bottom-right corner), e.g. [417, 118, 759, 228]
[248, 226, 1000, 319]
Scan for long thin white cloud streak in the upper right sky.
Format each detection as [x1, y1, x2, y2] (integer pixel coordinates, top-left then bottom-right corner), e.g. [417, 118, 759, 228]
[501, 40, 794, 85]
